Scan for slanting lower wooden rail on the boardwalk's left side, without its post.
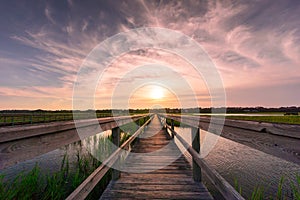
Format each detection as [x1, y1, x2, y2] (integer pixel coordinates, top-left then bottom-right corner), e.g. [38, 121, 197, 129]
[66, 115, 153, 200]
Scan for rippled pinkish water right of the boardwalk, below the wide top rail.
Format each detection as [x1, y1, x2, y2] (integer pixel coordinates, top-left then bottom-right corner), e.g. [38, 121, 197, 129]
[175, 127, 300, 199]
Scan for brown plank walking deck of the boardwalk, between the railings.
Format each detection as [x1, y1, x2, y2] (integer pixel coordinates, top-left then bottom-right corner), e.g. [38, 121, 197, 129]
[101, 116, 213, 199]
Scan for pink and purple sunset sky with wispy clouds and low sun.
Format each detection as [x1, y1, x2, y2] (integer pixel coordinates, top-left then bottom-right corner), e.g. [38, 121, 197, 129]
[0, 0, 300, 110]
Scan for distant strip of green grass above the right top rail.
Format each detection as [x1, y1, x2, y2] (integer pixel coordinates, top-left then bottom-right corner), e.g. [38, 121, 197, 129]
[226, 116, 300, 124]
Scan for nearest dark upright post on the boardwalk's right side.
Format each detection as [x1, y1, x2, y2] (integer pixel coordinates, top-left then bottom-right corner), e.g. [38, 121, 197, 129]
[192, 127, 202, 182]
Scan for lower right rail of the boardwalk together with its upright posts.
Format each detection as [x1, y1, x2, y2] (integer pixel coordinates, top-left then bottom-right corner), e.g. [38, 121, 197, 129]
[160, 115, 244, 200]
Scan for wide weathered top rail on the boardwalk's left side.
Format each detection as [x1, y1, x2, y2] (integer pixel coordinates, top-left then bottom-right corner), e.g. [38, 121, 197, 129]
[0, 115, 145, 169]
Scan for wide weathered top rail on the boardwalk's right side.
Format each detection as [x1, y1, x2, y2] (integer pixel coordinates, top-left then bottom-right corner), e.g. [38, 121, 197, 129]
[162, 115, 300, 164]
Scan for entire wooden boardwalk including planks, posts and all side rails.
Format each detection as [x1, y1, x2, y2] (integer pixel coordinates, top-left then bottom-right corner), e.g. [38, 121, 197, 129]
[0, 111, 300, 200]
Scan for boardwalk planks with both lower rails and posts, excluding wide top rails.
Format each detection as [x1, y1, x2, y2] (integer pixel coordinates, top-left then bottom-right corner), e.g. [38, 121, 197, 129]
[67, 114, 244, 200]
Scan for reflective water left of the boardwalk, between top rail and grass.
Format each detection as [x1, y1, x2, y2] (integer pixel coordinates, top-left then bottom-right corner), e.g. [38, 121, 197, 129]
[0, 130, 116, 181]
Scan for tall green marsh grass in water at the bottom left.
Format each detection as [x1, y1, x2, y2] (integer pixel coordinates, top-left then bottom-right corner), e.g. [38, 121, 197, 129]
[0, 154, 108, 200]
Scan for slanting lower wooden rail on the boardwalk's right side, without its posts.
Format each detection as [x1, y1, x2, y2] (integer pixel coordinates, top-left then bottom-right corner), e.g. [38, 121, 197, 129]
[166, 125, 244, 200]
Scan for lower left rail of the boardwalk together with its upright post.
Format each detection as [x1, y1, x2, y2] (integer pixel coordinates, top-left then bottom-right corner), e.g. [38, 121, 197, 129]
[67, 115, 153, 200]
